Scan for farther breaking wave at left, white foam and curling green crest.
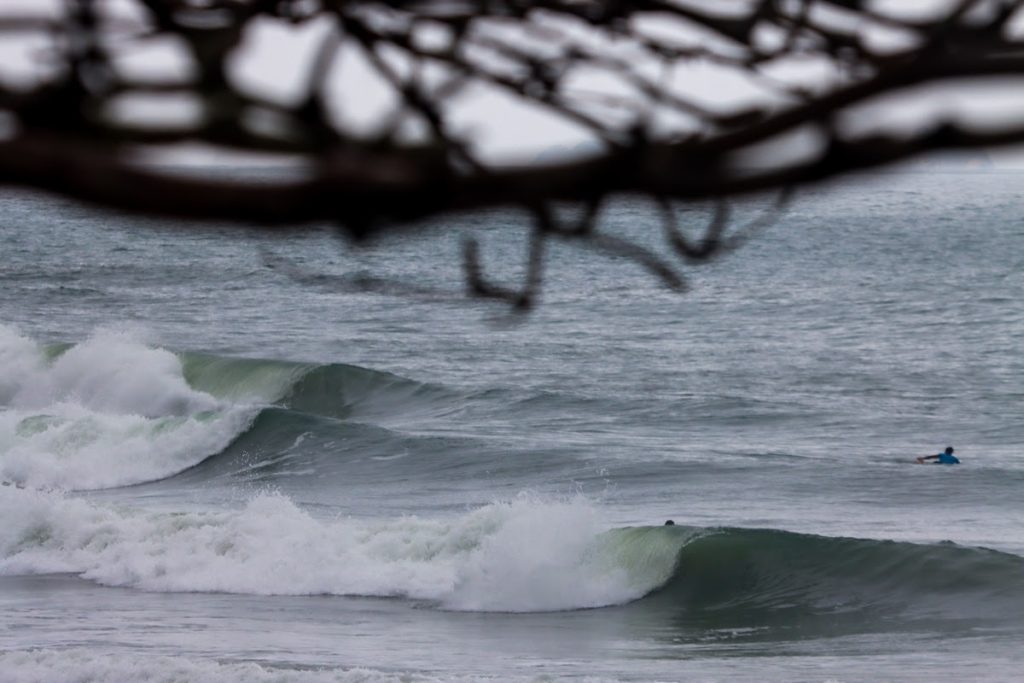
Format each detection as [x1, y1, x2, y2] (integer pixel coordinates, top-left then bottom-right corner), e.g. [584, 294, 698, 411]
[0, 326, 448, 490]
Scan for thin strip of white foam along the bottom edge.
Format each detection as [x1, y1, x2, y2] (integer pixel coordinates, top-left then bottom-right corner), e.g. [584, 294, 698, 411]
[0, 648, 622, 683]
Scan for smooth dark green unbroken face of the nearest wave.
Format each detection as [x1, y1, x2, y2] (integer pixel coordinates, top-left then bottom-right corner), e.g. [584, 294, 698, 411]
[609, 526, 1024, 637]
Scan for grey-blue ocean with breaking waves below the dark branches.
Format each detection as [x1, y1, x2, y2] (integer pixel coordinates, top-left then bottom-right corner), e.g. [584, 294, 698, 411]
[0, 166, 1024, 683]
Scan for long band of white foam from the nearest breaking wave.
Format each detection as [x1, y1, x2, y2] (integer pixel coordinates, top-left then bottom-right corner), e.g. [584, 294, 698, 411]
[0, 487, 673, 611]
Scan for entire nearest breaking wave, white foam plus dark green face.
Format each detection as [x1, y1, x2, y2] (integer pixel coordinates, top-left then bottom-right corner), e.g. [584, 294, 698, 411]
[0, 486, 1024, 625]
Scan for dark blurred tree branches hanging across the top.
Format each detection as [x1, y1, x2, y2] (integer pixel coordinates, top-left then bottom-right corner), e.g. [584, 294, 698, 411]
[0, 0, 1024, 306]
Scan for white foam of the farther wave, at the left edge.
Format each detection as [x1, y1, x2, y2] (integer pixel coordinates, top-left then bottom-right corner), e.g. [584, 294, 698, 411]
[0, 327, 257, 489]
